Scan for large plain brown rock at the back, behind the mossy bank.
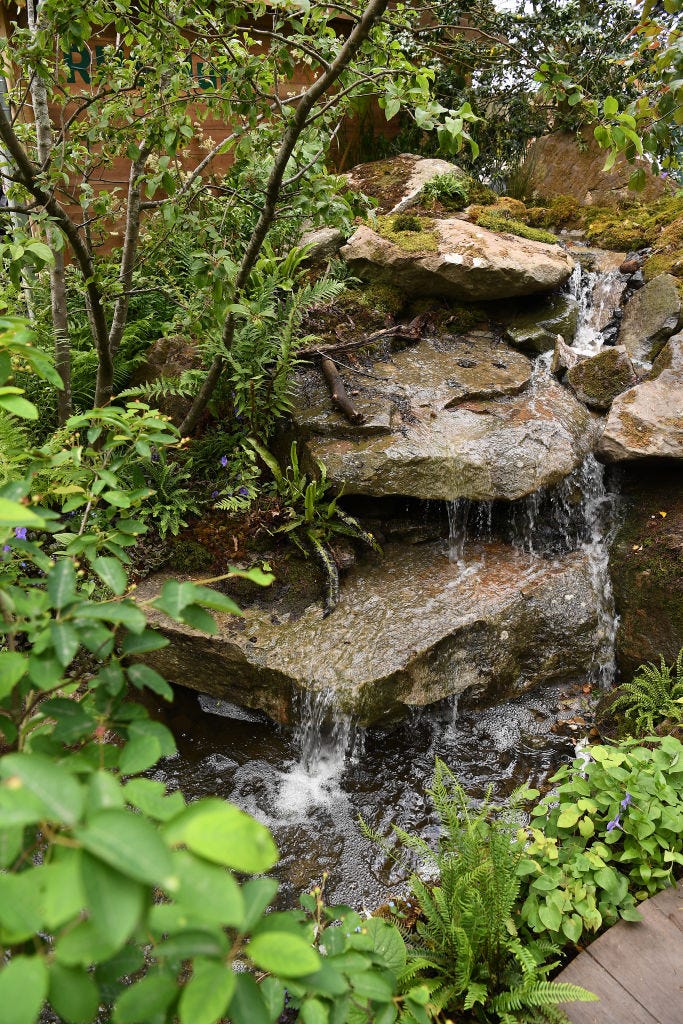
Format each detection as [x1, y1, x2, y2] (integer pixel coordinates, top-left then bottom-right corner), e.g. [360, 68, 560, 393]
[524, 129, 668, 206]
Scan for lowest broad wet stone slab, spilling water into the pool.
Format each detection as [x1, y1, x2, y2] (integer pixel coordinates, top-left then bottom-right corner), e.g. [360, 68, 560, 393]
[137, 543, 597, 724]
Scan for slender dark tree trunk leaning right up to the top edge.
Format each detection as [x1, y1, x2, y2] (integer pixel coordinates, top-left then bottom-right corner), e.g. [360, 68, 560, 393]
[180, 0, 388, 436]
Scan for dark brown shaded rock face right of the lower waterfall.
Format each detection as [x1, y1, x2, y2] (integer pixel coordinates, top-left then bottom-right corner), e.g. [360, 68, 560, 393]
[609, 462, 683, 680]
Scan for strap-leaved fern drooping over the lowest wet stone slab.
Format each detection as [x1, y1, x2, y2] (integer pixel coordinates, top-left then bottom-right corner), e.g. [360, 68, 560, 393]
[251, 439, 380, 614]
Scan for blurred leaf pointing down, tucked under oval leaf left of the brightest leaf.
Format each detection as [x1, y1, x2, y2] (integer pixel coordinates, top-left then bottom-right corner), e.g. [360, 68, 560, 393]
[81, 853, 145, 949]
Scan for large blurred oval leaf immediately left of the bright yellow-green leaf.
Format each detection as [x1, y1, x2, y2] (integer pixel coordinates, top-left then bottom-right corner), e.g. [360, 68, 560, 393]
[75, 808, 172, 887]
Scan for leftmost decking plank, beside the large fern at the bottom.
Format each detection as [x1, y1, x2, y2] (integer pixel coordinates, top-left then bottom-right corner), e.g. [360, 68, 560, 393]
[557, 952, 657, 1024]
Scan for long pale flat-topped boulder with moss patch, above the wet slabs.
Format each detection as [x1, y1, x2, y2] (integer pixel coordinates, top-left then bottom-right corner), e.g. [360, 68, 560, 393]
[341, 218, 573, 302]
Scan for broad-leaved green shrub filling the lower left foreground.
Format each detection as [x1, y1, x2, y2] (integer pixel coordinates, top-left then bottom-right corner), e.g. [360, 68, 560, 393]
[0, 322, 423, 1024]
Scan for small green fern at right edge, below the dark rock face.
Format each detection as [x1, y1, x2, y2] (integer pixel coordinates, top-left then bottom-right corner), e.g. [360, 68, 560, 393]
[610, 647, 683, 736]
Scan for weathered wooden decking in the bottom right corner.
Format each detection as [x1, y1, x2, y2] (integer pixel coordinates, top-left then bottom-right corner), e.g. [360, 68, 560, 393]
[556, 884, 683, 1024]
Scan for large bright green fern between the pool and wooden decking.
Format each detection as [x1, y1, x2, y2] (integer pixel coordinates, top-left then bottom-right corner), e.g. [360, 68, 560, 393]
[361, 759, 595, 1022]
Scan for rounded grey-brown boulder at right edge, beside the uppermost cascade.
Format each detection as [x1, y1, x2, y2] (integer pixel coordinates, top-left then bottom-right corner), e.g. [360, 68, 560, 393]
[617, 273, 681, 362]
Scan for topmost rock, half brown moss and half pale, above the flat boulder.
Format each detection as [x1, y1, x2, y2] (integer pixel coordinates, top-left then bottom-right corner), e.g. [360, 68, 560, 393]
[346, 153, 465, 213]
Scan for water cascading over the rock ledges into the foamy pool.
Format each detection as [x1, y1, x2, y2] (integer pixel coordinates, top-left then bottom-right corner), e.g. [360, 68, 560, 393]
[156, 251, 618, 908]
